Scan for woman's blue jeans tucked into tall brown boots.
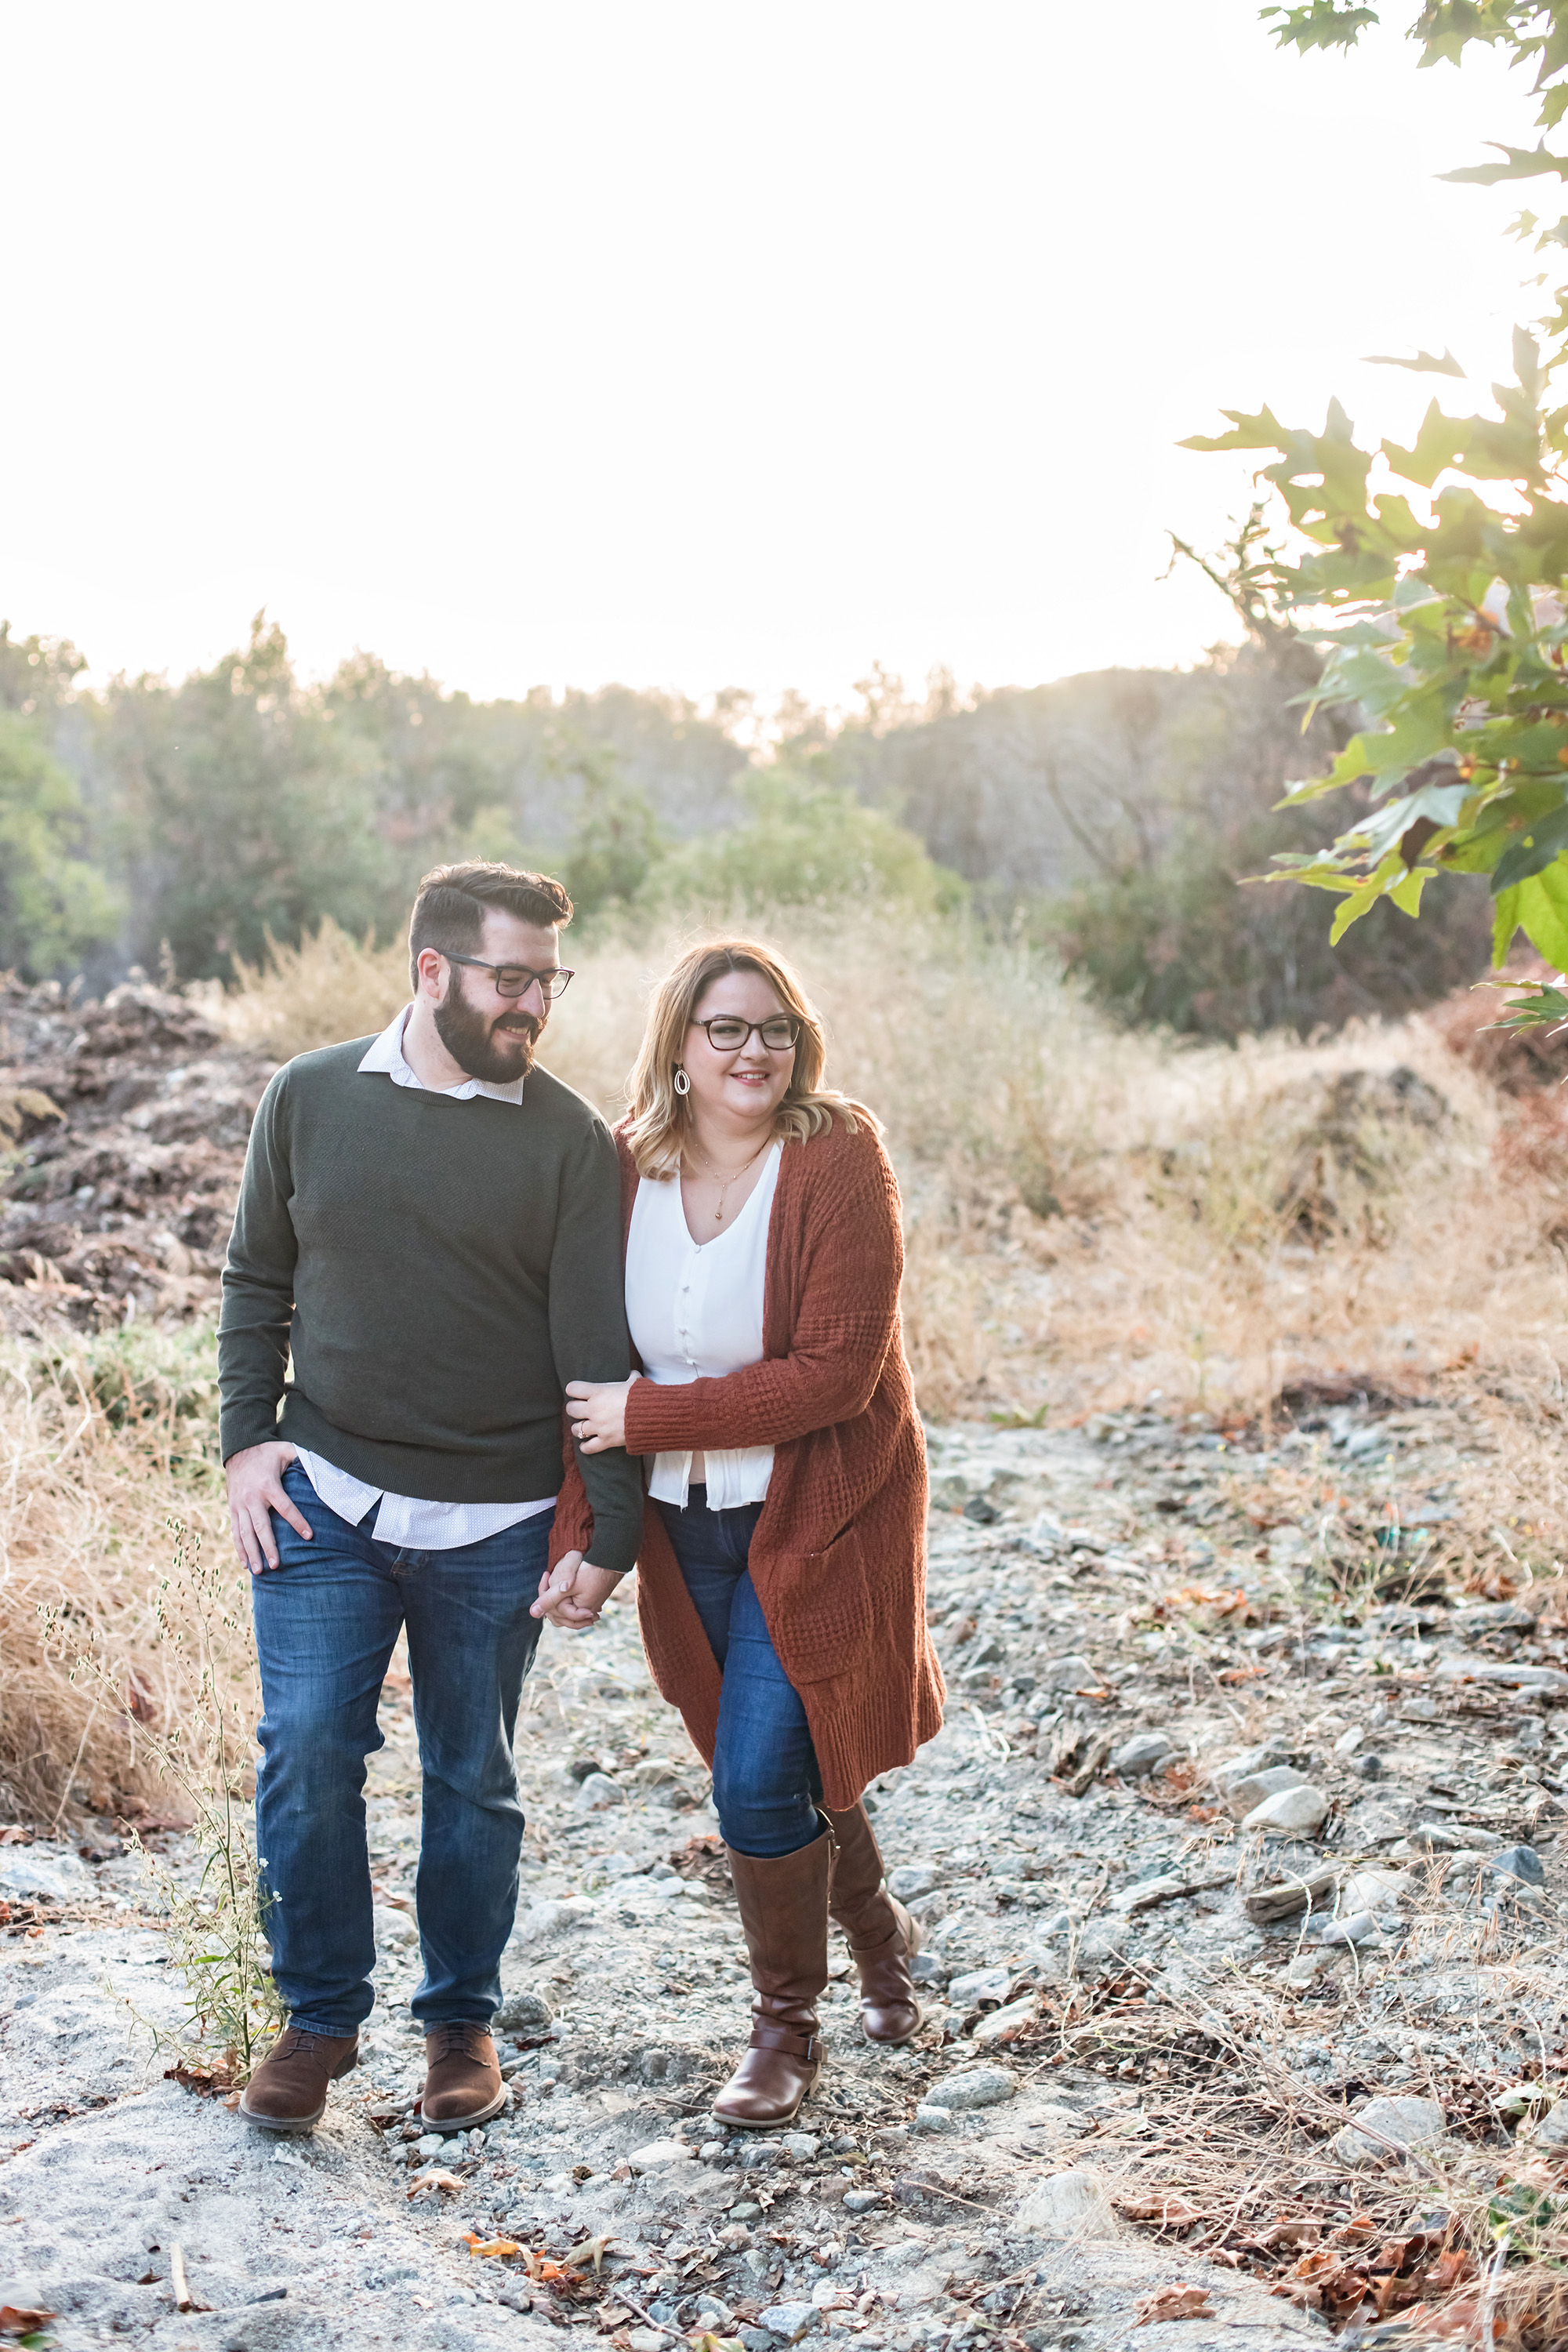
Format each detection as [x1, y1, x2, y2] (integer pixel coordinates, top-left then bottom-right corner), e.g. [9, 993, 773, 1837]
[656, 1486, 822, 1860]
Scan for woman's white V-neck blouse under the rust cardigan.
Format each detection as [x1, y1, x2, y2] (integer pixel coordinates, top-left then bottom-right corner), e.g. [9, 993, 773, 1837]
[626, 1143, 781, 1510]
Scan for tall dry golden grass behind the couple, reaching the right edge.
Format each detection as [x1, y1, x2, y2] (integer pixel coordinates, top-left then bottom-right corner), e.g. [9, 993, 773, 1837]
[208, 906, 1568, 1416]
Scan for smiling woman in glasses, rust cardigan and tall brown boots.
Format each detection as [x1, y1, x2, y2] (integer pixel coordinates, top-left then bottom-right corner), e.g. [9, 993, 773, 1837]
[536, 941, 942, 2129]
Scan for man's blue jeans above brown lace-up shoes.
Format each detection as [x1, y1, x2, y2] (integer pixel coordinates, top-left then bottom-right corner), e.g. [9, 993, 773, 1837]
[252, 1463, 550, 2034]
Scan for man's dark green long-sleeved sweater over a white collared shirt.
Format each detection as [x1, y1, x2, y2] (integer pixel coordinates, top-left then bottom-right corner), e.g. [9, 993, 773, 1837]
[219, 1037, 642, 1569]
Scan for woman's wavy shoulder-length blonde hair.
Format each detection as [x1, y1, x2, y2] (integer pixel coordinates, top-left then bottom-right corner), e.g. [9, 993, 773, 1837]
[626, 938, 869, 1178]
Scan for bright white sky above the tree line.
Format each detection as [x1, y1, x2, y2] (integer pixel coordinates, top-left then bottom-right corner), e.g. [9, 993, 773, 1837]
[0, 0, 1535, 703]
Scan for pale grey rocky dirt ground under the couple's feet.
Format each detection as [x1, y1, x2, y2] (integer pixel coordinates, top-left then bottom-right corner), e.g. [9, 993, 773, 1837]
[0, 1392, 1568, 2352]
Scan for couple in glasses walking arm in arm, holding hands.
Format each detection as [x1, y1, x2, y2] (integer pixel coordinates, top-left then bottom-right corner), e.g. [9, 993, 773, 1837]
[219, 863, 942, 2131]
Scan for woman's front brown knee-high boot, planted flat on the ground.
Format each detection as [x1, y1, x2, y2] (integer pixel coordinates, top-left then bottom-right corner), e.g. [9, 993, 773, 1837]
[713, 1830, 832, 2131]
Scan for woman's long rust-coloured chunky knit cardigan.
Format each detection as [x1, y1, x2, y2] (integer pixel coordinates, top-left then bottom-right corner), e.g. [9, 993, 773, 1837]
[550, 1120, 945, 1811]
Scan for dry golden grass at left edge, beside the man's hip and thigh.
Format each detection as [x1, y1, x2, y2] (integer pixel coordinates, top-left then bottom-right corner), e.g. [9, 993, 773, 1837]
[0, 1331, 239, 1823]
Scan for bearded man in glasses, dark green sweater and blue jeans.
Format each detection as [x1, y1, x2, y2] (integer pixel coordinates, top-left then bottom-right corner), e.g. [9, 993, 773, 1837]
[219, 863, 642, 2131]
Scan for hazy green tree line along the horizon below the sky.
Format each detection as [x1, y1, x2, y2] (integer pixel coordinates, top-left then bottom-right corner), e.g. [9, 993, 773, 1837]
[0, 593, 1488, 1037]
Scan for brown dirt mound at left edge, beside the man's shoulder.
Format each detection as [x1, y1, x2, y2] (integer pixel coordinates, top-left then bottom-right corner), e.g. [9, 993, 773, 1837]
[0, 978, 273, 1331]
